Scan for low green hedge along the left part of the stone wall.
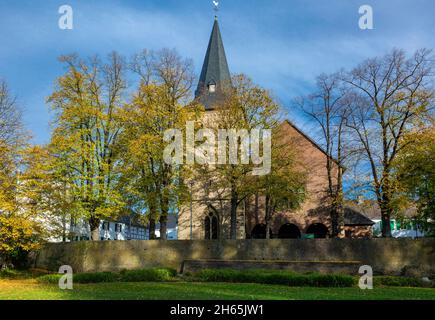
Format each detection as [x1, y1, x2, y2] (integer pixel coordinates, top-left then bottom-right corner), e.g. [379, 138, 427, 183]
[38, 268, 177, 283]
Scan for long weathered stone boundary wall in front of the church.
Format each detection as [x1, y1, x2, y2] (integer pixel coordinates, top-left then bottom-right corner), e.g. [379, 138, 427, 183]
[31, 238, 435, 274]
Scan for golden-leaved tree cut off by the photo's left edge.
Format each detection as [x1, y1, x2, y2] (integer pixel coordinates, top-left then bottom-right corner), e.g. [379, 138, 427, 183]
[0, 81, 40, 266]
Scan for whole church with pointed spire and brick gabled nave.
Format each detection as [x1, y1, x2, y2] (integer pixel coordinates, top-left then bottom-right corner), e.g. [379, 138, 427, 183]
[178, 18, 374, 240]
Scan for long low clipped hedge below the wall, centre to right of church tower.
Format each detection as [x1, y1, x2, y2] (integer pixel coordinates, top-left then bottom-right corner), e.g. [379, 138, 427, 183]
[194, 269, 356, 287]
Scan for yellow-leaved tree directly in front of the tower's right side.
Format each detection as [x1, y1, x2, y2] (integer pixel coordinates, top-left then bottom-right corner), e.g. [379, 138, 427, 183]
[207, 75, 280, 239]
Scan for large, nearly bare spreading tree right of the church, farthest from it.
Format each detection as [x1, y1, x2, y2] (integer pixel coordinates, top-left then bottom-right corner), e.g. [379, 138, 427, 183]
[343, 49, 434, 237]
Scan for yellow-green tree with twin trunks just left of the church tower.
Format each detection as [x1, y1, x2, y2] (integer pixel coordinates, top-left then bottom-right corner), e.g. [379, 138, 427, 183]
[119, 49, 200, 240]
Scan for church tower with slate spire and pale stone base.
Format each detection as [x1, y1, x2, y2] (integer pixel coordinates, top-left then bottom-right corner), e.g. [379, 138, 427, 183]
[178, 17, 245, 240]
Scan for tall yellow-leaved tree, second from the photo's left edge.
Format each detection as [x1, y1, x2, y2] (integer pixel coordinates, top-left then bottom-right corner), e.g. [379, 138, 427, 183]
[48, 53, 126, 240]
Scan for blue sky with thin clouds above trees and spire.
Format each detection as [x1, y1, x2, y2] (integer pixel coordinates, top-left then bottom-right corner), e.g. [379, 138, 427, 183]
[0, 0, 435, 143]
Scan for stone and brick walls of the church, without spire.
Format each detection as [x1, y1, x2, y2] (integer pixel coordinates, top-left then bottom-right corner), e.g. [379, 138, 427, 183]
[179, 118, 350, 240]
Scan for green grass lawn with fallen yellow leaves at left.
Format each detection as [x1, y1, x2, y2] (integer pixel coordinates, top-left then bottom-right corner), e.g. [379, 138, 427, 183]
[0, 279, 435, 300]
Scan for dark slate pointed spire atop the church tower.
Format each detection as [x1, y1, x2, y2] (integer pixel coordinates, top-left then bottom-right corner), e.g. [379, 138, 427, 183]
[195, 16, 231, 110]
